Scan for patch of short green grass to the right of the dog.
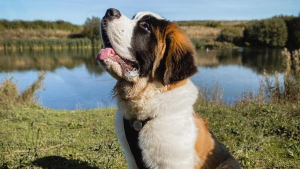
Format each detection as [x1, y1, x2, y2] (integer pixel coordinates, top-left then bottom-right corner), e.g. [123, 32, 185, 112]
[195, 102, 300, 168]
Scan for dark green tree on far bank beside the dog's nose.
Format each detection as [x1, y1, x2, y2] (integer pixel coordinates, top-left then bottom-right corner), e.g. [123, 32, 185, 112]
[82, 16, 101, 44]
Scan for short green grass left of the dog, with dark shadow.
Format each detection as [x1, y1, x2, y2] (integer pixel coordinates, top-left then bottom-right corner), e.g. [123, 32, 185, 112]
[0, 105, 126, 168]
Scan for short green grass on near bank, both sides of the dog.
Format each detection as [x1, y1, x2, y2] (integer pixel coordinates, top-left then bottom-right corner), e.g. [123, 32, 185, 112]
[0, 99, 300, 168]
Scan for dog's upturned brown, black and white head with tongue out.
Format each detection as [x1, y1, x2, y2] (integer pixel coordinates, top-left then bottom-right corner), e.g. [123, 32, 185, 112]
[97, 8, 197, 86]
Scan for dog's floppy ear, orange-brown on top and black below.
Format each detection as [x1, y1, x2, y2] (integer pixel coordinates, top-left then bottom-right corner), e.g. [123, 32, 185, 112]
[160, 22, 197, 85]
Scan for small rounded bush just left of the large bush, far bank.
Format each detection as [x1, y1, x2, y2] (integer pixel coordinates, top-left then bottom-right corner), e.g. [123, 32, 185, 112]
[218, 28, 242, 44]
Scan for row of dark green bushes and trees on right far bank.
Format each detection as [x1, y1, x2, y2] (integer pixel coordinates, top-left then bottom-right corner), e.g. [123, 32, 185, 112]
[218, 14, 300, 49]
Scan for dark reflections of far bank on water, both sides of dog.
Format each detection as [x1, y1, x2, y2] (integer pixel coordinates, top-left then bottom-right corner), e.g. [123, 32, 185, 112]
[0, 49, 283, 75]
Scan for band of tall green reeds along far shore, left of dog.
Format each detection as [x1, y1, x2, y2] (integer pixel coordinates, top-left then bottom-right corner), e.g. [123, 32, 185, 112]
[0, 38, 101, 50]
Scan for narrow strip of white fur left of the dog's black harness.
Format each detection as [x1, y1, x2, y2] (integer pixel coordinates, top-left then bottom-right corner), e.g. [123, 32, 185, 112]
[115, 110, 138, 169]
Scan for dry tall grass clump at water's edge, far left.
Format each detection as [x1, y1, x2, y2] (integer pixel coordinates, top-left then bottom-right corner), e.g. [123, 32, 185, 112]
[0, 72, 46, 109]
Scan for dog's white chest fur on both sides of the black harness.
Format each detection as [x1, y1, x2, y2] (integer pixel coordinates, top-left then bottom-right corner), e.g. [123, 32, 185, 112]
[115, 80, 199, 169]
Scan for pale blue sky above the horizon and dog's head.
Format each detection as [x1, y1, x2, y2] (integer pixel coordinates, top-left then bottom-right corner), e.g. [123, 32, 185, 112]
[0, 0, 300, 25]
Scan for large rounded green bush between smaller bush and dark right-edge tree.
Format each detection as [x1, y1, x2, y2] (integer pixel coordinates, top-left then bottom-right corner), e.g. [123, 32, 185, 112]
[244, 18, 288, 47]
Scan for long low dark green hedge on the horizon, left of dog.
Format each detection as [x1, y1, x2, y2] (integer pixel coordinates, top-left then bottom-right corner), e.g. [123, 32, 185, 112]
[0, 19, 81, 31]
